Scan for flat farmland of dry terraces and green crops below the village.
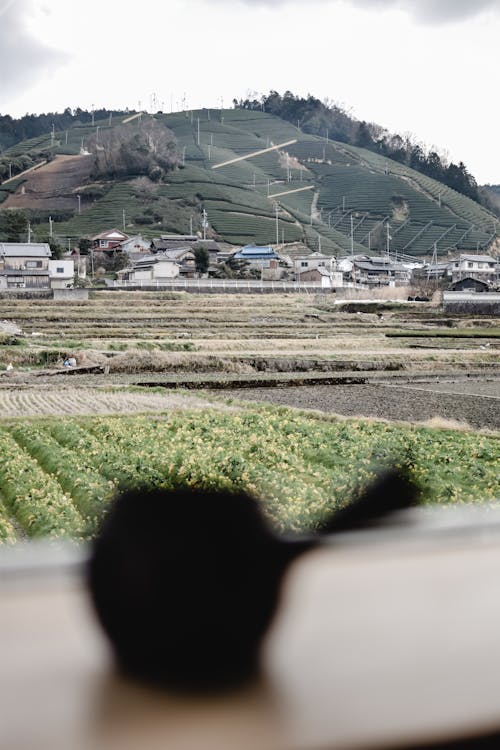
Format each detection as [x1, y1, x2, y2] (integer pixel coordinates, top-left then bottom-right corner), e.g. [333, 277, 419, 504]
[0, 291, 500, 541]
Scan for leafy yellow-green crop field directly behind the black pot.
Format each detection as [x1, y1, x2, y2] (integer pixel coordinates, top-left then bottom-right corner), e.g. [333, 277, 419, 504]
[0, 408, 500, 541]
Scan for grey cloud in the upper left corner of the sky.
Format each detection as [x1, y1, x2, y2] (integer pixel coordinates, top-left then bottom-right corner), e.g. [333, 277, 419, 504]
[0, 0, 67, 107]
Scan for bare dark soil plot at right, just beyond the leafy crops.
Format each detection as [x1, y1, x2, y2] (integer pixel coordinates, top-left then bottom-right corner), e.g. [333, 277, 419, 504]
[218, 381, 500, 430]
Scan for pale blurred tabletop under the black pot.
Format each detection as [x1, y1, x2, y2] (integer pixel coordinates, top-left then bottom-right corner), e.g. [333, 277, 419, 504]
[0, 510, 500, 750]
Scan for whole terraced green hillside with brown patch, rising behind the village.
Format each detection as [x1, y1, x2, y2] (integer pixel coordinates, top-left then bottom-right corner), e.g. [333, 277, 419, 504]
[0, 109, 497, 256]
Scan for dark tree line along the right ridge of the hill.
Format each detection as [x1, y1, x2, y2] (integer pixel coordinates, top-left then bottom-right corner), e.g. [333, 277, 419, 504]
[233, 91, 482, 203]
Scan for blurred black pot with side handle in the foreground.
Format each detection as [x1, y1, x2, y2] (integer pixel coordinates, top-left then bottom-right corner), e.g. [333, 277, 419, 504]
[89, 475, 416, 691]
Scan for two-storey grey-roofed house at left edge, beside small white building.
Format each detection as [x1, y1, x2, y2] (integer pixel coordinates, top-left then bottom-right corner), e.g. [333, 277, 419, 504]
[0, 248, 52, 289]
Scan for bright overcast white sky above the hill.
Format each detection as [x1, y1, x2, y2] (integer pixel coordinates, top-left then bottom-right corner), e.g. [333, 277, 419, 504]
[0, 0, 500, 184]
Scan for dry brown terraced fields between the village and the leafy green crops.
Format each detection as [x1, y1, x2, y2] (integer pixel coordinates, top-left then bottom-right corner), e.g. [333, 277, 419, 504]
[0, 291, 500, 429]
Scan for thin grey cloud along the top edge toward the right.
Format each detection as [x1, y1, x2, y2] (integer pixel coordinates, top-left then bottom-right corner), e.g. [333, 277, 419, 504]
[211, 0, 500, 23]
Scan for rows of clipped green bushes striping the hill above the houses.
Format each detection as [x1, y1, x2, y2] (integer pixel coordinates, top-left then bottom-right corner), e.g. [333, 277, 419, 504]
[6, 109, 496, 255]
